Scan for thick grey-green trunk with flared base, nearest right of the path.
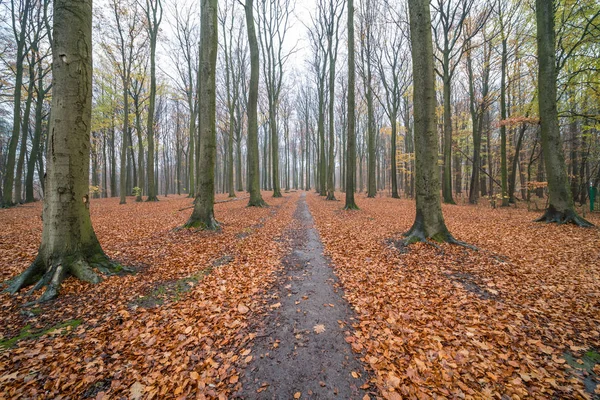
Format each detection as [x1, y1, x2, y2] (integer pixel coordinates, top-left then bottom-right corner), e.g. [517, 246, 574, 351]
[405, 0, 454, 243]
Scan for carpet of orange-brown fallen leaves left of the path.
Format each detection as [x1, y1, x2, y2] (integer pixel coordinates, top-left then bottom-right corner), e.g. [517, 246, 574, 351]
[0, 192, 295, 399]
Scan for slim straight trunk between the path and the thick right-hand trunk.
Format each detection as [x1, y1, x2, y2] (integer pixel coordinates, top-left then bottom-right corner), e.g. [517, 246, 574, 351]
[344, 0, 358, 210]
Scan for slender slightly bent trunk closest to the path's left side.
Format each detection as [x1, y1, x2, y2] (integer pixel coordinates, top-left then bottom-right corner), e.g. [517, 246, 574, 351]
[244, 0, 267, 207]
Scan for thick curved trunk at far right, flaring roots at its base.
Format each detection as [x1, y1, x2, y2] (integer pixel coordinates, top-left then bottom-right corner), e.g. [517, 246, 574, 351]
[535, 0, 593, 227]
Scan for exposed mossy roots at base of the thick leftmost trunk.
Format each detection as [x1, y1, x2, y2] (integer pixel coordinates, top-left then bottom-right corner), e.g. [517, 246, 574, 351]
[6, 252, 128, 303]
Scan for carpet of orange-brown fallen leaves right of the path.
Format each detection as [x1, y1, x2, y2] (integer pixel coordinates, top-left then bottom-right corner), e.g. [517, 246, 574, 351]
[307, 196, 600, 399]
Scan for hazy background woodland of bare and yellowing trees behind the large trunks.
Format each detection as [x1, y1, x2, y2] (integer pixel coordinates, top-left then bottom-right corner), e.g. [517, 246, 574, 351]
[0, 0, 600, 228]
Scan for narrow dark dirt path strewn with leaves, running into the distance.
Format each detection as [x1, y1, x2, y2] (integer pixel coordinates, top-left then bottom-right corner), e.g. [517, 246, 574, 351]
[237, 193, 368, 399]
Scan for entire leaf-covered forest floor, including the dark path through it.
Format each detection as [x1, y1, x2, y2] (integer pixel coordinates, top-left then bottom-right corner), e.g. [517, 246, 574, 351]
[0, 192, 600, 399]
